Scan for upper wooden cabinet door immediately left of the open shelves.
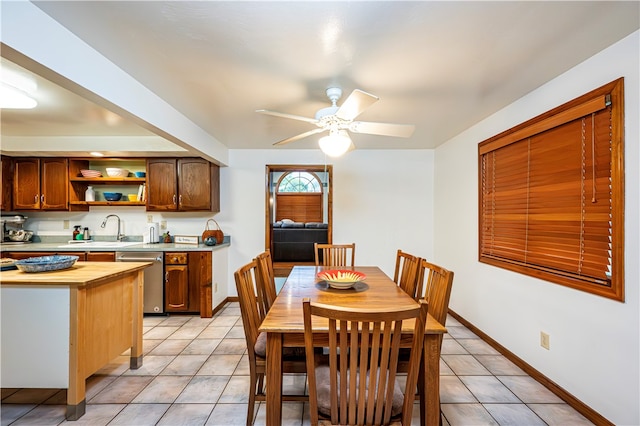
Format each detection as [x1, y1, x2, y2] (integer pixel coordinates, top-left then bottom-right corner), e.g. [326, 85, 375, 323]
[40, 158, 69, 210]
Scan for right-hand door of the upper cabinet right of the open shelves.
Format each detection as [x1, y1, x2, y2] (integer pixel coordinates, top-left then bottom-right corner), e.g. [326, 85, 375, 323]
[178, 158, 212, 211]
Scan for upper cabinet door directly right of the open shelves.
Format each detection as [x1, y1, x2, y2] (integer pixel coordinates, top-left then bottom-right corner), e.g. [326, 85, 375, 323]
[147, 158, 178, 211]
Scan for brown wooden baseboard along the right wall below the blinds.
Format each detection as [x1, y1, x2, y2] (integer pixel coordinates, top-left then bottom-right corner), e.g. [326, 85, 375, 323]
[449, 309, 614, 426]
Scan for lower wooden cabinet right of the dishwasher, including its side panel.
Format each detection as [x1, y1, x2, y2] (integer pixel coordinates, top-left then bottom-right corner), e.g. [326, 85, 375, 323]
[164, 251, 213, 318]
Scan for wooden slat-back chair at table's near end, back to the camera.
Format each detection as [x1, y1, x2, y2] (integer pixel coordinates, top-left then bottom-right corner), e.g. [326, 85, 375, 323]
[302, 298, 427, 425]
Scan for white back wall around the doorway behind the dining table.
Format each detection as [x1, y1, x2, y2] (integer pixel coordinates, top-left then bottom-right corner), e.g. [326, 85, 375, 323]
[217, 146, 433, 295]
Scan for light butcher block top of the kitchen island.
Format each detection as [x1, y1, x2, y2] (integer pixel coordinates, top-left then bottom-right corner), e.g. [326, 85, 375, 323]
[0, 262, 151, 286]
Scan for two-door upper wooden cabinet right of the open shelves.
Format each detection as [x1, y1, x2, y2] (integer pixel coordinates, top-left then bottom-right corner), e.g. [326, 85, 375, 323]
[147, 158, 220, 212]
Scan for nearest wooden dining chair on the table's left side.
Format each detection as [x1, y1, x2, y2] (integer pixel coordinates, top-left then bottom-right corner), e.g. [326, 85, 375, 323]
[234, 259, 308, 425]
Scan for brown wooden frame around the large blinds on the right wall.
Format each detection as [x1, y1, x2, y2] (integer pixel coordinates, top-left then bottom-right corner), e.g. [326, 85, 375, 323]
[478, 78, 624, 302]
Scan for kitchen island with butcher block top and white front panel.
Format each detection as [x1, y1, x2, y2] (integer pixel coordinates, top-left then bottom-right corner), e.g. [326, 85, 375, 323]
[0, 262, 150, 420]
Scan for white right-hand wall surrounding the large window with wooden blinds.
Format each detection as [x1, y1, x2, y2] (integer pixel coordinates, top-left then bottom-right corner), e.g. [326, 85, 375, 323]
[435, 32, 640, 425]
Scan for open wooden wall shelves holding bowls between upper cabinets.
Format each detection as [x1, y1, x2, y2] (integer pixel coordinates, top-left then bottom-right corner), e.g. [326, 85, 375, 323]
[69, 158, 146, 211]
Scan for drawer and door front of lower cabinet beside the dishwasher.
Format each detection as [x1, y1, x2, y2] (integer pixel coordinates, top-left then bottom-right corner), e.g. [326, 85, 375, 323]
[164, 253, 189, 312]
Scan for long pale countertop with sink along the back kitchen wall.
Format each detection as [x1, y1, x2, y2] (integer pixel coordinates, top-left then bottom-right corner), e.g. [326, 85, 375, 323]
[0, 237, 231, 253]
